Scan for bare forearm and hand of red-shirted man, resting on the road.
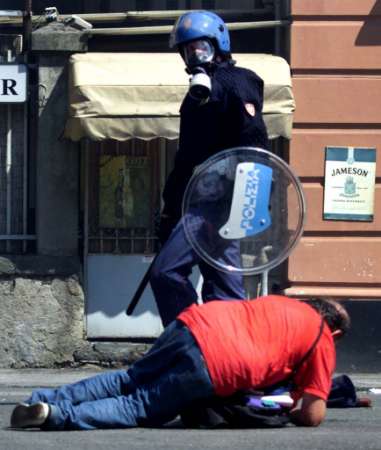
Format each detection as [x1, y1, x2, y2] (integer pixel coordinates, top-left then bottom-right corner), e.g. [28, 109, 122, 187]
[290, 394, 327, 427]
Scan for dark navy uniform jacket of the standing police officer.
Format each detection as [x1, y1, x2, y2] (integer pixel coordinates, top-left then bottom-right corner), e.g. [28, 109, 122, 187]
[163, 63, 269, 220]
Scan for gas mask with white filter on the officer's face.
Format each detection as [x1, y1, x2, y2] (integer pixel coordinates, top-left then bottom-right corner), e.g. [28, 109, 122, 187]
[182, 39, 215, 102]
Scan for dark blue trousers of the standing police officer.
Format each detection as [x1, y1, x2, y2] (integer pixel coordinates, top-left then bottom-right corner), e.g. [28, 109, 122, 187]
[150, 217, 245, 326]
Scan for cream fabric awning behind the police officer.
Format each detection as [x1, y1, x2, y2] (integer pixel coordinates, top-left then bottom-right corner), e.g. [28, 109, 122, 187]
[64, 53, 295, 141]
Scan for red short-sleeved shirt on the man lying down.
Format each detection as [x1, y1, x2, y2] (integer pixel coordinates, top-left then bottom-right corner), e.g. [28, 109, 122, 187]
[178, 295, 336, 400]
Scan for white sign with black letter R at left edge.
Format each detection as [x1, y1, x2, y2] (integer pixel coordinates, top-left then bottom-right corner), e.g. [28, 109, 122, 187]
[0, 64, 27, 103]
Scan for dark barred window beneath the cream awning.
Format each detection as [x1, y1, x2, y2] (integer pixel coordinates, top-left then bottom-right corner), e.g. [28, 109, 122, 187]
[83, 139, 162, 254]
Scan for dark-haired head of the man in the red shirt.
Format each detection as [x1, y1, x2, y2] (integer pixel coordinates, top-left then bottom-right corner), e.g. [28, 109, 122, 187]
[303, 298, 351, 335]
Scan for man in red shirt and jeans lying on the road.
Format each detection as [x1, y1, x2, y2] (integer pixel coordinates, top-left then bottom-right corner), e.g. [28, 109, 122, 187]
[11, 295, 350, 430]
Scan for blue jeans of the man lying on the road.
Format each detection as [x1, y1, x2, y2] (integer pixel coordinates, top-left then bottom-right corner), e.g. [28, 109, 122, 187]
[27, 321, 214, 430]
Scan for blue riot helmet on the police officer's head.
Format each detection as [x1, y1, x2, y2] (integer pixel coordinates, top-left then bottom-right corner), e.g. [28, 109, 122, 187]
[169, 11, 230, 54]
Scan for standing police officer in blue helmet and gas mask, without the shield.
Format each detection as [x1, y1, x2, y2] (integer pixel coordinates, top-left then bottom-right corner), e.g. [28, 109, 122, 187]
[150, 11, 268, 326]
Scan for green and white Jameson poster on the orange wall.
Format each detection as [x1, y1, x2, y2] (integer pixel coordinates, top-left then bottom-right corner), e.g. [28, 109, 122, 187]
[323, 146, 376, 222]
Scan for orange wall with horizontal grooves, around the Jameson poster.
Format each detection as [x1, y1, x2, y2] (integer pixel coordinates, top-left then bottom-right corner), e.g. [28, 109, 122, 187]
[286, 0, 381, 298]
